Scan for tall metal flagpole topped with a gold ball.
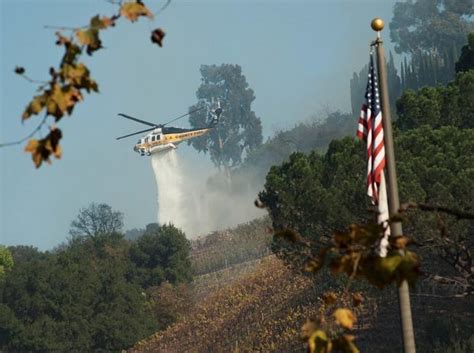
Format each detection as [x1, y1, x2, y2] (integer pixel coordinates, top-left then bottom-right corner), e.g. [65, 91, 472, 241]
[371, 18, 416, 353]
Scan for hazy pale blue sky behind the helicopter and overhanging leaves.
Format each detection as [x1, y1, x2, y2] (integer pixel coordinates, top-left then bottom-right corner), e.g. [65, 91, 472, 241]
[0, 0, 395, 250]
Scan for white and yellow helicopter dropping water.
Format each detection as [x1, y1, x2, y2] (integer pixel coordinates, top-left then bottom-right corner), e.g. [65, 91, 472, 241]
[117, 102, 222, 156]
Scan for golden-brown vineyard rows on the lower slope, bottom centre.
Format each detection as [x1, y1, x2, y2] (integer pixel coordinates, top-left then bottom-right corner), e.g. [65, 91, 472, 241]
[130, 256, 326, 352]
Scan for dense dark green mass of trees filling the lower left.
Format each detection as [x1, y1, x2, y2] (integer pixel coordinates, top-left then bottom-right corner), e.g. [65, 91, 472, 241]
[0, 213, 192, 352]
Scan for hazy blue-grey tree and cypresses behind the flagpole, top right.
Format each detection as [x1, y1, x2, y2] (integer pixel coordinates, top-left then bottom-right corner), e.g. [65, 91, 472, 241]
[351, 0, 474, 115]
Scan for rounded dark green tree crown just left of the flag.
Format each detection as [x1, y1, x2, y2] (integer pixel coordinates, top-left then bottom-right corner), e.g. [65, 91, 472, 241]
[259, 137, 368, 248]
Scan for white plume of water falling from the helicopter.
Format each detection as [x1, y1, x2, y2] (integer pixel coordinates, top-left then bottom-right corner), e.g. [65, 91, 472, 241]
[151, 150, 265, 238]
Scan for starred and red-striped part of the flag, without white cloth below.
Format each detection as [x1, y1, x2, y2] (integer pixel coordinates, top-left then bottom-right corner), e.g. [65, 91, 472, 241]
[357, 53, 385, 205]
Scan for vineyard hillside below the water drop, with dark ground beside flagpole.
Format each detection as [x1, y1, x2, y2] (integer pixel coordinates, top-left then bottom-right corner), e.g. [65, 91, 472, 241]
[129, 214, 474, 353]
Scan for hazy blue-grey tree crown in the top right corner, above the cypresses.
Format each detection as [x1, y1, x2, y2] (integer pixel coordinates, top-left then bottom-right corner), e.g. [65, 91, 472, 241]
[390, 0, 474, 56]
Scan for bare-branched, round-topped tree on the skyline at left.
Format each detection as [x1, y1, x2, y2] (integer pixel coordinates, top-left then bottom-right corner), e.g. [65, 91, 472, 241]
[69, 203, 123, 237]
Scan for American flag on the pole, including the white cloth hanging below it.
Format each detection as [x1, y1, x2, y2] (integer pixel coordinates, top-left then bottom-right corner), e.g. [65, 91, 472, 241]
[357, 53, 390, 257]
